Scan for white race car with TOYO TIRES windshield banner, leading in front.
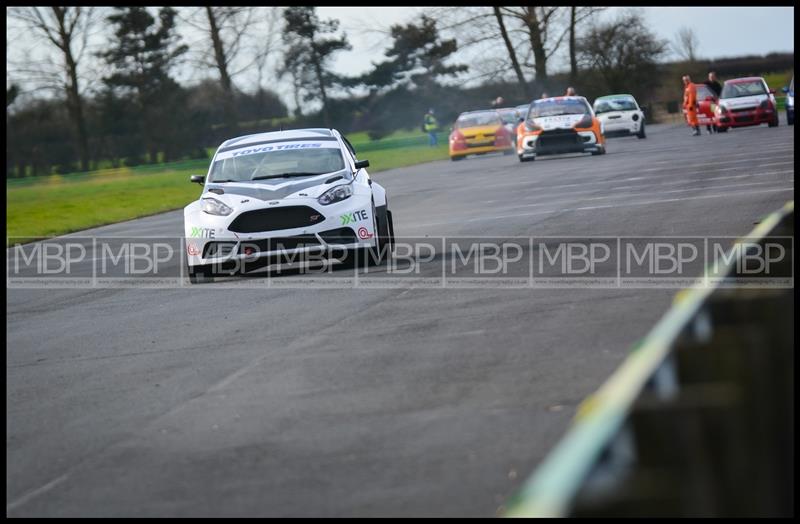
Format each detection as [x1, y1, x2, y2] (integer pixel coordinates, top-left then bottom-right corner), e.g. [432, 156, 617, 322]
[183, 129, 394, 283]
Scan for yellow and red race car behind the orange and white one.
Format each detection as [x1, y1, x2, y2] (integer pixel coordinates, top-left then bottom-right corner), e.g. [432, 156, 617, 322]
[450, 110, 514, 160]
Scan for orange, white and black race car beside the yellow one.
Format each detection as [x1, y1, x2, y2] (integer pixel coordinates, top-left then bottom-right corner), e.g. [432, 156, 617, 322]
[517, 96, 606, 162]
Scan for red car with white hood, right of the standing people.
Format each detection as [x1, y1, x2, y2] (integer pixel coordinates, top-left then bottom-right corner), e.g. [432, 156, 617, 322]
[715, 76, 778, 132]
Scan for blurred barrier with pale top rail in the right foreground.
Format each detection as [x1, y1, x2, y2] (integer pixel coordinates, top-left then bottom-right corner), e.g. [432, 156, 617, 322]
[505, 202, 794, 517]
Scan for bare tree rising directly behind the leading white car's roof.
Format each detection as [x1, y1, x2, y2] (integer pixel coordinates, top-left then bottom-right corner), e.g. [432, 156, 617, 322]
[181, 6, 278, 129]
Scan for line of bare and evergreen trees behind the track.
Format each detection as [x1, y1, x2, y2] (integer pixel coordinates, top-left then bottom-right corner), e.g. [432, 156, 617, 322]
[6, 6, 792, 177]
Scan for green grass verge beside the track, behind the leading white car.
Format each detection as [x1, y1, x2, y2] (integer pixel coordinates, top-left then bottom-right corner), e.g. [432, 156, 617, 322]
[6, 131, 448, 246]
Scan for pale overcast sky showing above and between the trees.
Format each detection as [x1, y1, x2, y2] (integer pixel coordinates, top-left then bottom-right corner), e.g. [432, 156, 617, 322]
[6, 7, 794, 112]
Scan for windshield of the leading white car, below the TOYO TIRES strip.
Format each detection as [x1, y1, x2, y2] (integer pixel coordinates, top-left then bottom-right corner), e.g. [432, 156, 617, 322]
[209, 147, 344, 182]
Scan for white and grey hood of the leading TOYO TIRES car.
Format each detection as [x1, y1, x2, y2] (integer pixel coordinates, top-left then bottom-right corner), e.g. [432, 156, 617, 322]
[201, 169, 351, 206]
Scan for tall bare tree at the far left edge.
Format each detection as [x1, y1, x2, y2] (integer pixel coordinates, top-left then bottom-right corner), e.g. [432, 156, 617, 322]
[9, 6, 96, 171]
